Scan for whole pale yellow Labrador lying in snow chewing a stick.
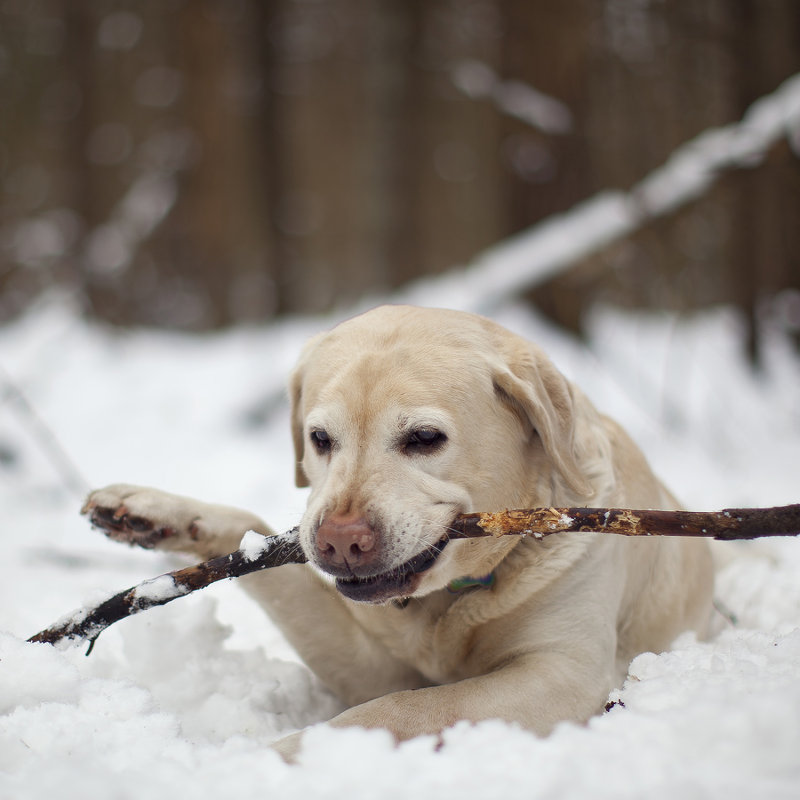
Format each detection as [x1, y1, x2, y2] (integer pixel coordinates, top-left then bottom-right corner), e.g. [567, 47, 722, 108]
[87, 307, 712, 752]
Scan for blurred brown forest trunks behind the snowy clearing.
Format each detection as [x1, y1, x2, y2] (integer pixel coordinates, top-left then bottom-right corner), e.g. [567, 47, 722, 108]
[0, 0, 800, 362]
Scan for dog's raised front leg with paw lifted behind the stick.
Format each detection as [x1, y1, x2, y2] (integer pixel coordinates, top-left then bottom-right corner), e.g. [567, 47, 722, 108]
[84, 484, 426, 704]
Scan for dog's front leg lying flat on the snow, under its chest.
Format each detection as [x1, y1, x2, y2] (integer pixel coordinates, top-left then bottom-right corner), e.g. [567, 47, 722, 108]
[275, 543, 622, 760]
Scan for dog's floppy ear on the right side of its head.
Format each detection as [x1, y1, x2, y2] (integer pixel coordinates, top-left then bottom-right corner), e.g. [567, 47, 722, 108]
[493, 342, 592, 497]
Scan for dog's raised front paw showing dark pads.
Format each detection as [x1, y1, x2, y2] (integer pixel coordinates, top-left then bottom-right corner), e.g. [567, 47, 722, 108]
[81, 483, 197, 549]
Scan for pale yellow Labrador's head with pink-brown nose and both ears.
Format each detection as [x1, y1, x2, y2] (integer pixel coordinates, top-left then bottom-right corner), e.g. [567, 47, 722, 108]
[290, 306, 590, 602]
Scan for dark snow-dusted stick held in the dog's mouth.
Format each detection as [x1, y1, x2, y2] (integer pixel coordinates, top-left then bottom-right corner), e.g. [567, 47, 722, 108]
[28, 504, 800, 655]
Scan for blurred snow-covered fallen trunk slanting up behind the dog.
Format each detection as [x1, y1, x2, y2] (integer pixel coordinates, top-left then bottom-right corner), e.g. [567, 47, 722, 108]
[406, 74, 800, 312]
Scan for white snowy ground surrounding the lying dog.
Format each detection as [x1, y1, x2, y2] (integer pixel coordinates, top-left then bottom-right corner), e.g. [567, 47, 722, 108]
[0, 296, 800, 800]
